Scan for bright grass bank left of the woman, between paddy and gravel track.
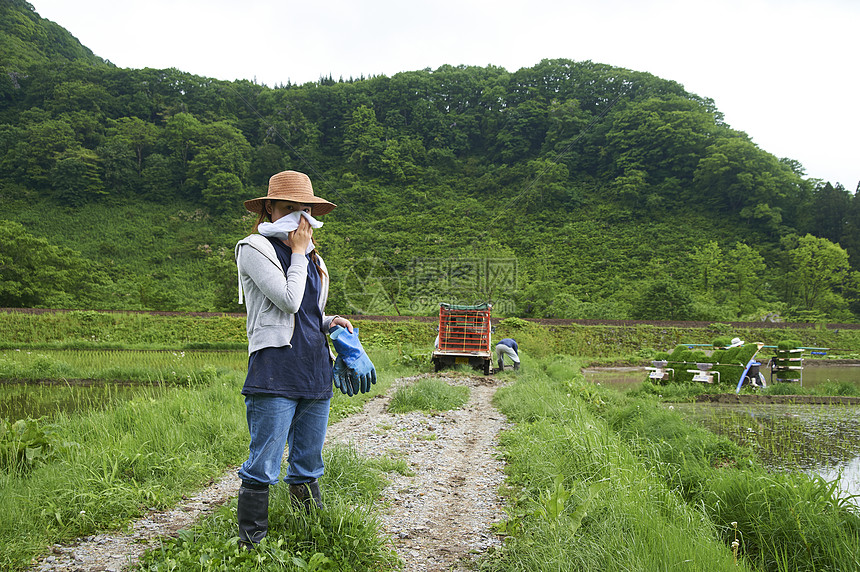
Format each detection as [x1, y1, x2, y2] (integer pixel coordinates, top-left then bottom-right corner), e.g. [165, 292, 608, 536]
[0, 374, 247, 569]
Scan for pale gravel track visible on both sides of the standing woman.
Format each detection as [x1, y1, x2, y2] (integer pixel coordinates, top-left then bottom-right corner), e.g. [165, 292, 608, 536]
[31, 373, 505, 572]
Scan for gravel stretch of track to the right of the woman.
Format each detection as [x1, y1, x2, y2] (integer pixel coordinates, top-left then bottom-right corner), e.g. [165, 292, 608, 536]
[328, 373, 505, 572]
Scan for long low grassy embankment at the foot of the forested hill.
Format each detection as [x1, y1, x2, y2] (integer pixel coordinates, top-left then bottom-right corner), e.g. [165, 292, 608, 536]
[0, 311, 860, 358]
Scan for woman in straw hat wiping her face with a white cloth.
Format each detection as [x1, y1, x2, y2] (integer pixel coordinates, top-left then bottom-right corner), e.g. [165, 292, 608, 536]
[235, 171, 353, 548]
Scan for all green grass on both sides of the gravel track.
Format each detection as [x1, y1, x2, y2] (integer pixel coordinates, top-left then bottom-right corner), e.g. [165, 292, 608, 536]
[0, 326, 860, 571]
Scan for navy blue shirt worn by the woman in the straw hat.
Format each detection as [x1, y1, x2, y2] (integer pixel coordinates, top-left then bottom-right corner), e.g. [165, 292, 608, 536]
[242, 238, 332, 399]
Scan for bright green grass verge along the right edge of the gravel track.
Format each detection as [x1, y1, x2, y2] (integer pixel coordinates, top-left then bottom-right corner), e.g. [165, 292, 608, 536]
[483, 360, 736, 571]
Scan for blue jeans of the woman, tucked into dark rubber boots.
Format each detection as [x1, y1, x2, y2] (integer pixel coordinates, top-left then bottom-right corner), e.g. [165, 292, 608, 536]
[239, 395, 331, 485]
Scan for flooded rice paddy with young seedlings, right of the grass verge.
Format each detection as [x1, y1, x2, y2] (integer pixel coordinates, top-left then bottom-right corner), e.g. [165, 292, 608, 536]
[583, 364, 860, 507]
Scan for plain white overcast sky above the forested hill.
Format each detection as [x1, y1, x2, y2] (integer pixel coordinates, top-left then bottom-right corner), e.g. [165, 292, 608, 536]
[29, 0, 860, 191]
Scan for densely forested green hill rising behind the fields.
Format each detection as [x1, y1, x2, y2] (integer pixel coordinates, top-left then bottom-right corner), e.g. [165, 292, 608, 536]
[0, 0, 860, 322]
